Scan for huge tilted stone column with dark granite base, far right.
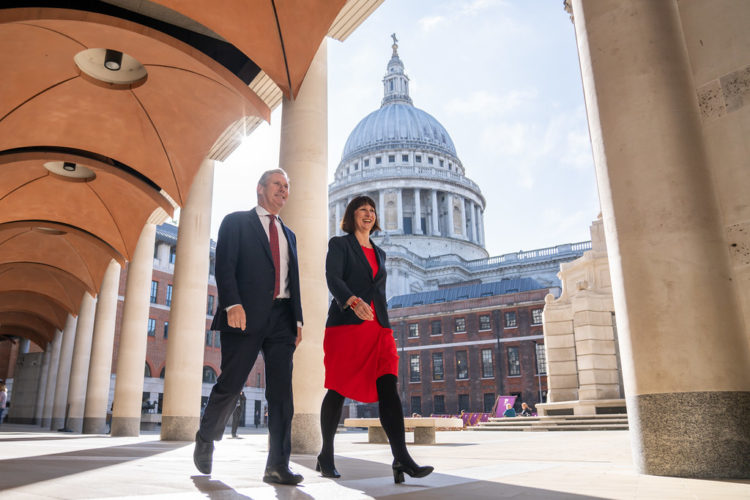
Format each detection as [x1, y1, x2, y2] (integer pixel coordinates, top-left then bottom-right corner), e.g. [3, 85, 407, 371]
[573, 0, 750, 478]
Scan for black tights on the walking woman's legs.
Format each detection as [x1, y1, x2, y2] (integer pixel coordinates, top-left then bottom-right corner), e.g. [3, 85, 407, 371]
[320, 374, 416, 465]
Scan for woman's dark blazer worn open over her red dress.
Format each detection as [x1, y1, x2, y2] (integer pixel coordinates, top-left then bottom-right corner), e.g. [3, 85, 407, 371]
[326, 234, 391, 328]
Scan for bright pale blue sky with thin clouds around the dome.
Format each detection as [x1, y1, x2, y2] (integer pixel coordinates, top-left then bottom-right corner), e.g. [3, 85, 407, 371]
[211, 0, 599, 256]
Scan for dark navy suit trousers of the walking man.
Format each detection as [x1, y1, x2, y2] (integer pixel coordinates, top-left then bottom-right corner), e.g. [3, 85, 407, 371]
[198, 300, 297, 467]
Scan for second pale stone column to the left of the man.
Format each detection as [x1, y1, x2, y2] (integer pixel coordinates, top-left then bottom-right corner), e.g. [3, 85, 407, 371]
[112, 222, 156, 436]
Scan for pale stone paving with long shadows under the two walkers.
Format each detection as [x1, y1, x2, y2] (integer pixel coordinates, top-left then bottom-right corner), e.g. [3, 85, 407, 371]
[0, 424, 750, 500]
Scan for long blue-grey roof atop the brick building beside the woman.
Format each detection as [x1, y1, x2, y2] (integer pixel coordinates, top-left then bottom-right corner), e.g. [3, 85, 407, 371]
[388, 278, 545, 309]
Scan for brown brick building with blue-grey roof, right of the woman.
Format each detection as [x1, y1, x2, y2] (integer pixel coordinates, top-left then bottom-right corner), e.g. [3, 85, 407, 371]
[388, 278, 549, 415]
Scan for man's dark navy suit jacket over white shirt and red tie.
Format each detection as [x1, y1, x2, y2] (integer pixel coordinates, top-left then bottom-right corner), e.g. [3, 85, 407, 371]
[211, 209, 302, 334]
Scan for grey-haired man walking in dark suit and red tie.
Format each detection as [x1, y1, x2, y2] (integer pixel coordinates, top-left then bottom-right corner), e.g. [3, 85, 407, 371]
[193, 169, 303, 484]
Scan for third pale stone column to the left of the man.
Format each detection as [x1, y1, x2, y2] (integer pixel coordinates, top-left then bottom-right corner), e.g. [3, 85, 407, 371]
[82, 260, 120, 434]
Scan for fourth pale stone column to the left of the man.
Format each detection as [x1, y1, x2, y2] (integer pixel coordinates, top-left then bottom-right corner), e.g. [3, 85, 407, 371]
[65, 292, 96, 432]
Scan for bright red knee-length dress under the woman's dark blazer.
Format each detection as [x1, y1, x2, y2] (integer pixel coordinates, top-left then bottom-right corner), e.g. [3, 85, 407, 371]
[323, 247, 398, 403]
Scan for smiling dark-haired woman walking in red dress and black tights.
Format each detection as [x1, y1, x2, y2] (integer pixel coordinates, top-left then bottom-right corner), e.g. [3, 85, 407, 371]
[316, 196, 433, 483]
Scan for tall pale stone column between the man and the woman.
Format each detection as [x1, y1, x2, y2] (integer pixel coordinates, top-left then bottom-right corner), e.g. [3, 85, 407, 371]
[279, 40, 328, 453]
